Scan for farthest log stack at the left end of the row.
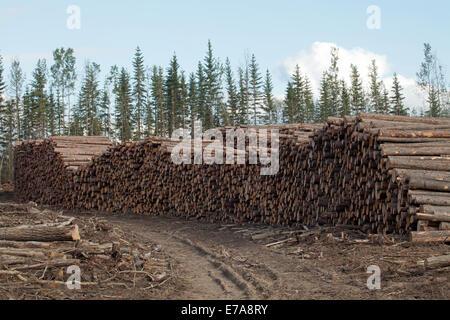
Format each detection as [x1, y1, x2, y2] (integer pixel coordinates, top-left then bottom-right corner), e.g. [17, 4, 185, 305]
[14, 137, 112, 205]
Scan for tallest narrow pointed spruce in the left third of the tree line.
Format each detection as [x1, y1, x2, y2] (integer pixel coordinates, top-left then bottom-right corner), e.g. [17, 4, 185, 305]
[133, 47, 146, 141]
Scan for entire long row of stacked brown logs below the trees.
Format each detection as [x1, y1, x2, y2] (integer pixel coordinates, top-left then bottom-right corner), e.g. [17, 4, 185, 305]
[12, 114, 450, 242]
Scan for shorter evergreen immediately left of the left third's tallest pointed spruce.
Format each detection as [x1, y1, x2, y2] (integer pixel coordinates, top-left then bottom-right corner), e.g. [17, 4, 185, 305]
[115, 68, 133, 142]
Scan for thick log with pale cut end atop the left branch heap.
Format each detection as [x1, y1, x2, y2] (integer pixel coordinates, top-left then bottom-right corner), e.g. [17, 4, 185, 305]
[0, 225, 80, 242]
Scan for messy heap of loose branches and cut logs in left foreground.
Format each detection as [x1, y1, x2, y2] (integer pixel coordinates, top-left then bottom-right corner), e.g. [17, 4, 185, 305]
[0, 202, 171, 299]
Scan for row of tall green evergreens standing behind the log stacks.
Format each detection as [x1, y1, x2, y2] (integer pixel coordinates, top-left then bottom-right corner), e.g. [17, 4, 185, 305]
[0, 41, 449, 182]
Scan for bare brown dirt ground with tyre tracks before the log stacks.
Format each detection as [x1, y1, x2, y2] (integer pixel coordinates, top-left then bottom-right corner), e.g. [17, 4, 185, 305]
[0, 190, 450, 300]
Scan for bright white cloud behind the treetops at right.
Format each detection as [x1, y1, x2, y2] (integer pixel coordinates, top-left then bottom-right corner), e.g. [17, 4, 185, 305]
[279, 42, 424, 113]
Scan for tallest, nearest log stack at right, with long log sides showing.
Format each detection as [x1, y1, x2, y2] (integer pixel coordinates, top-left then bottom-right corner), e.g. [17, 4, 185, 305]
[305, 114, 450, 242]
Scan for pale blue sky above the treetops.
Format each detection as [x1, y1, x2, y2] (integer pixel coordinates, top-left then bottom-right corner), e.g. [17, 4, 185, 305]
[0, 0, 450, 107]
